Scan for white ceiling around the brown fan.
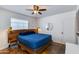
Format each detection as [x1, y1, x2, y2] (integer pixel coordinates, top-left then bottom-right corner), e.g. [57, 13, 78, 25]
[0, 5, 76, 18]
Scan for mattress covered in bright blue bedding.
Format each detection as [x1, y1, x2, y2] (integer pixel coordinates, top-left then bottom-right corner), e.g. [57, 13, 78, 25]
[18, 33, 52, 49]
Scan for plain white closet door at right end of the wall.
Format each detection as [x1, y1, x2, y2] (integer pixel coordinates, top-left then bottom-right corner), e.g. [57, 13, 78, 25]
[63, 12, 76, 43]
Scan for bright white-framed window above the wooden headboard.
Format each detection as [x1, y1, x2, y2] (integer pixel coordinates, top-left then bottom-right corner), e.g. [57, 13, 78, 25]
[11, 18, 28, 30]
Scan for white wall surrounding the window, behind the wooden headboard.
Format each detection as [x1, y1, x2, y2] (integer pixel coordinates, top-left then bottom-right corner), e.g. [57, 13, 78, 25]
[0, 9, 37, 50]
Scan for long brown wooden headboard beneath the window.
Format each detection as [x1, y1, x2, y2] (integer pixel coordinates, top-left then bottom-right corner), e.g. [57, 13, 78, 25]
[8, 29, 38, 43]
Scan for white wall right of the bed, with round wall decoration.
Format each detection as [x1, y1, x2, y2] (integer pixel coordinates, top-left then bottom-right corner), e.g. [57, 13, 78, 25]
[39, 11, 76, 43]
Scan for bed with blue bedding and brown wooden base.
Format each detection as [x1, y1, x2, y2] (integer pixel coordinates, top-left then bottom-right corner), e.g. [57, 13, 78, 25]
[18, 32, 52, 53]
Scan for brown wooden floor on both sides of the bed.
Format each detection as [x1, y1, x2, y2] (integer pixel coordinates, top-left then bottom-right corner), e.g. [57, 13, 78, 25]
[0, 42, 65, 54]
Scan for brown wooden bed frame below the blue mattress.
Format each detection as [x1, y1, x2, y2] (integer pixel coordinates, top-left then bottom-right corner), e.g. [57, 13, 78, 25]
[18, 41, 52, 54]
